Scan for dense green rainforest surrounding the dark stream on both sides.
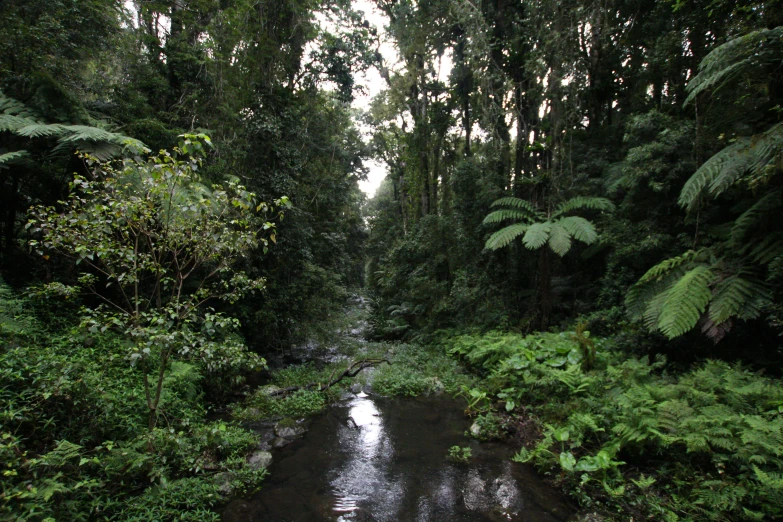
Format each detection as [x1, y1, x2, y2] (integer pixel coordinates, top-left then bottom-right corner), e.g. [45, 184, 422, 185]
[0, 0, 783, 521]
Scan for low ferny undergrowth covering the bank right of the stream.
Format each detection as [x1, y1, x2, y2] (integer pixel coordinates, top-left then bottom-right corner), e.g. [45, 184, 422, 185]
[443, 332, 783, 521]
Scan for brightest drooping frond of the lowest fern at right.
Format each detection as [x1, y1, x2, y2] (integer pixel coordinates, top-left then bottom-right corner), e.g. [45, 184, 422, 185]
[658, 265, 715, 339]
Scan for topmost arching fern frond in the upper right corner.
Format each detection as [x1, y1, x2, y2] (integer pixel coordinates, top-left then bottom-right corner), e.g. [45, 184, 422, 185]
[684, 27, 783, 105]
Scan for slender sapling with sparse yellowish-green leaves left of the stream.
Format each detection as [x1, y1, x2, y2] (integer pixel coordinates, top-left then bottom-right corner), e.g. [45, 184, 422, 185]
[28, 135, 288, 430]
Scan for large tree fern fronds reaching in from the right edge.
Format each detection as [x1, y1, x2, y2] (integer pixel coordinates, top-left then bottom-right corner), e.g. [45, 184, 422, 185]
[626, 27, 783, 342]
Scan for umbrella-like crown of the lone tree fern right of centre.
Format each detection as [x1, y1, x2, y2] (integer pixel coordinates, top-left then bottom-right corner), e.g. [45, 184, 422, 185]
[484, 197, 614, 257]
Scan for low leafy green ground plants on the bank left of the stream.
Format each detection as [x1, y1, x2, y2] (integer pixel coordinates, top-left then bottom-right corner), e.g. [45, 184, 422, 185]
[0, 284, 265, 521]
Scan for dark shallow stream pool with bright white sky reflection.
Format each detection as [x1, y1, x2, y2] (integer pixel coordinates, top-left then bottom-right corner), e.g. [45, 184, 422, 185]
[223, 393, 571, 522]
